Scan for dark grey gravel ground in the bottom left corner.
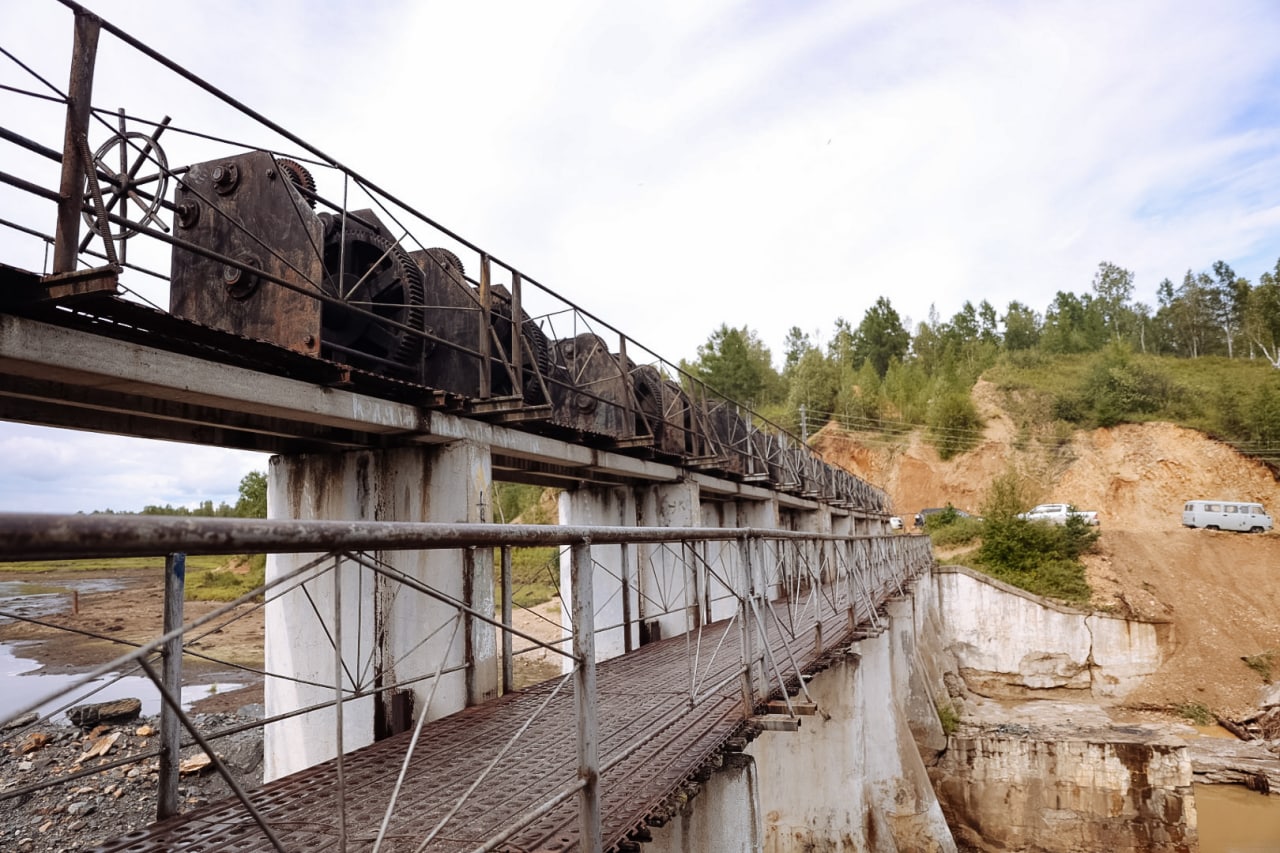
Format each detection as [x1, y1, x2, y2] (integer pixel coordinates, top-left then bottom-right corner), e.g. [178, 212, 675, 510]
[0, 706, 262, 852]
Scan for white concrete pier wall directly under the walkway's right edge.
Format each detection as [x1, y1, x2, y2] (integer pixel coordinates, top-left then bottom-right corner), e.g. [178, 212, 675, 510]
[643, 573, 956, 853]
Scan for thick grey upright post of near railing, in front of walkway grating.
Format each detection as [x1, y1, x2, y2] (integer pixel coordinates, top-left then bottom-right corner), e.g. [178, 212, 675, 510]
[570, 539, 602, 853]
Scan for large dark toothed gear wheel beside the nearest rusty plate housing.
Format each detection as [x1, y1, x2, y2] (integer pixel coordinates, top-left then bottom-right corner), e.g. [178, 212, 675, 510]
[320, 225, 425, 369]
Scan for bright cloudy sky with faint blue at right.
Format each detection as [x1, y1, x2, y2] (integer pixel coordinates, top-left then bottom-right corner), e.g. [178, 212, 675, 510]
[0, 0, 1280, 511]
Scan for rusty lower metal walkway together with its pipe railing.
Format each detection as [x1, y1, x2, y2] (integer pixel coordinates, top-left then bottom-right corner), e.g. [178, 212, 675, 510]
[0, 515, 932, 853]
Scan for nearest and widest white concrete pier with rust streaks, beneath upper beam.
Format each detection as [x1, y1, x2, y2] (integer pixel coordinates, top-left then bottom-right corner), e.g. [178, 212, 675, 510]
[265, 442, 499, 780]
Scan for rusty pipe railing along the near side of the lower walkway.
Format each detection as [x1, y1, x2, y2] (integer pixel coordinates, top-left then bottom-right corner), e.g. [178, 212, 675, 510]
[0, 514, 929, 850]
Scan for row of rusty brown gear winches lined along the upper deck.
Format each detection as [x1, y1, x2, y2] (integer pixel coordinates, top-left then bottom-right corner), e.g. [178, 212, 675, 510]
[170, 151, 872, 500]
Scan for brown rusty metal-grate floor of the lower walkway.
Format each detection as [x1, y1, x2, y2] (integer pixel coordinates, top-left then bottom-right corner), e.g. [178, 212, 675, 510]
[95, 588, 869, 853]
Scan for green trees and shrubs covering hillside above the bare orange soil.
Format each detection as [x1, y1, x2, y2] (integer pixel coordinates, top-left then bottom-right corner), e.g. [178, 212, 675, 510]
[680, 260, 1280, 460]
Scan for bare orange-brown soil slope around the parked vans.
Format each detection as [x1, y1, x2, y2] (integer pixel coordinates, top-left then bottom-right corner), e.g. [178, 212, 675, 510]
[815, 383, 1280, 717]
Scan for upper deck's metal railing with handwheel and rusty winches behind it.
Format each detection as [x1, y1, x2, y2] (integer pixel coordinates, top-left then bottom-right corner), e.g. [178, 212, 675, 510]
[0, 0, 888, 514]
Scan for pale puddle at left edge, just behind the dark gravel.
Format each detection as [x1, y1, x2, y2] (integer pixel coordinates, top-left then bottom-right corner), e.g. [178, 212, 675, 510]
[0, 646, 244, 721]
